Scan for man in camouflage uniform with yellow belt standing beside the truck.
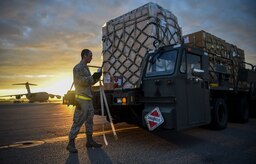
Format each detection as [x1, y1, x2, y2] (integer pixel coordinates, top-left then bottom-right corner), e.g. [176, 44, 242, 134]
[67, 49, 102, 153]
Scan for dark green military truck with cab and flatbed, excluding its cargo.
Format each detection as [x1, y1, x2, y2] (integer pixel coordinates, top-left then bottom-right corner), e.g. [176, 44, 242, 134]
[96, 41, 256, 129]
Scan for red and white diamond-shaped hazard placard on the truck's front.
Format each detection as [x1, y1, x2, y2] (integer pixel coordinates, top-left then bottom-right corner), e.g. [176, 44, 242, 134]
[145, 107, 164, 131]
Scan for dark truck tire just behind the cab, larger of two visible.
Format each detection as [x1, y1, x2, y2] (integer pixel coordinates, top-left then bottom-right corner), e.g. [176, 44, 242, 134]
[211, 98, 228, 130]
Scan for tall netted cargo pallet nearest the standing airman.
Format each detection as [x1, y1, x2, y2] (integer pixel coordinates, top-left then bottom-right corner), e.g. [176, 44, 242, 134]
[102, 3, 182, 89]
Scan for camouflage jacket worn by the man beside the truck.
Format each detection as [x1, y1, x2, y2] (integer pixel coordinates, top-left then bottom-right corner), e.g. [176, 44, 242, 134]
[73, 61, 97, 98]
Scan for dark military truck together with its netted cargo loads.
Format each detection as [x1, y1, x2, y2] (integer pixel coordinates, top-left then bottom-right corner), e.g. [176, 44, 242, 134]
[90, 3, 256, 130]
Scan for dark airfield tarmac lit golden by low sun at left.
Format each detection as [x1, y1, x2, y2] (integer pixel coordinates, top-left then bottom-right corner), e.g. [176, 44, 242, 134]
[0, 103, 256, 164]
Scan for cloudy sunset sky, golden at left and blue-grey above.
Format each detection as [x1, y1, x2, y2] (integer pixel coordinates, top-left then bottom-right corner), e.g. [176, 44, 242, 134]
[0, 0, 256, 95]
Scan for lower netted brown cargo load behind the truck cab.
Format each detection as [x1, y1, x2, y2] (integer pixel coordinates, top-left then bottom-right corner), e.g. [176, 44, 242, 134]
[183, 30, 245, 88]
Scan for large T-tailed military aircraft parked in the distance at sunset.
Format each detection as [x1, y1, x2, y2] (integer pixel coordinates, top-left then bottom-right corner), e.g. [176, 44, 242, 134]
[1, 82, 61, 102]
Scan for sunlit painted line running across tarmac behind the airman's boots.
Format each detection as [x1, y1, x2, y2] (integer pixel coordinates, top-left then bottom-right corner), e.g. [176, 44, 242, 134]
[0, 126, 139, 150]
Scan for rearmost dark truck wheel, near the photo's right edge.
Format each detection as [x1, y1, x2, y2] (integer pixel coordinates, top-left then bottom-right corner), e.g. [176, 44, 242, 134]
[236, 98, 249, 123]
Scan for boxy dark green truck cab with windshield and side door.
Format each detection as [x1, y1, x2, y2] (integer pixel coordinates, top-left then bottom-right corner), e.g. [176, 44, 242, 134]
[139, 45, 211, 130]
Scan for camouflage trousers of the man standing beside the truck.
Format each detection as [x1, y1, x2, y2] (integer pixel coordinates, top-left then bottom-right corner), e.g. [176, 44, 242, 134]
[69, 99, 94, 139]
